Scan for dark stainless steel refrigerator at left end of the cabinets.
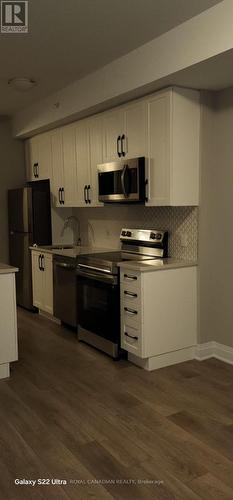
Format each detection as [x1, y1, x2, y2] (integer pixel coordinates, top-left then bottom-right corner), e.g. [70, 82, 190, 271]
[8, 180, 52, 309]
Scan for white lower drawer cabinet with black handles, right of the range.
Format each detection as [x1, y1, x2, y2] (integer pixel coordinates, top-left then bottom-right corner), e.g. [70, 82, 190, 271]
[120, 266, 197, 366]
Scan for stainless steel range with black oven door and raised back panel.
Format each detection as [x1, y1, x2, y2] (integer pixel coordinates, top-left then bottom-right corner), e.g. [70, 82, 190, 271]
[77, 228, 168, 358]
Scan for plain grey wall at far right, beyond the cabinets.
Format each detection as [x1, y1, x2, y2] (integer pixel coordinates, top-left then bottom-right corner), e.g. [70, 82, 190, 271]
[199, 89, 233, 347]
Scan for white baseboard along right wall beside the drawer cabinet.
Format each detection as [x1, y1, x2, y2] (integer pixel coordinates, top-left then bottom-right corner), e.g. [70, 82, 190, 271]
[195, 342, 233, 365]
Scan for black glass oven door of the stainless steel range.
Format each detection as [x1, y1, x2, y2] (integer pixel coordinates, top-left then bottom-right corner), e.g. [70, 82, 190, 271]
[77, 266, 120, 344]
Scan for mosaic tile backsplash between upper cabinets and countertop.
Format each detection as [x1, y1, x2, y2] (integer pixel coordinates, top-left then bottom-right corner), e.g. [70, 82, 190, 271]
[74, 205, 198, 260]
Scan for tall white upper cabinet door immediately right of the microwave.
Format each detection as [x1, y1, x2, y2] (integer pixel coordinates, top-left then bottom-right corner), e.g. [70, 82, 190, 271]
[148, 92, 171, 205]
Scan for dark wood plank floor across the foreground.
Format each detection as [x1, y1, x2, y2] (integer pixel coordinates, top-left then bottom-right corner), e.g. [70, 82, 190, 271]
[0, 310, 233, 500]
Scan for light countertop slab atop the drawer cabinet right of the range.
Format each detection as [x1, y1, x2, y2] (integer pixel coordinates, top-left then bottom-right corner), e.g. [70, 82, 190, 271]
[118, 257, 197, 272]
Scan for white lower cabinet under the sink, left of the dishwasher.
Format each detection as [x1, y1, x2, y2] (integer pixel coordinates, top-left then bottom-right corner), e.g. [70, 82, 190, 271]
[32, 250, 53, 314]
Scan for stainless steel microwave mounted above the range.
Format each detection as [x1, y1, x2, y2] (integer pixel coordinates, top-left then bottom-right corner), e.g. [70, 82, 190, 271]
[97, 157, 146, 203]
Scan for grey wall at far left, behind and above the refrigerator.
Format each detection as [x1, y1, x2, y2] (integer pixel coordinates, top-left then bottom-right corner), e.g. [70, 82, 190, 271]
[0, 119, 25, 263]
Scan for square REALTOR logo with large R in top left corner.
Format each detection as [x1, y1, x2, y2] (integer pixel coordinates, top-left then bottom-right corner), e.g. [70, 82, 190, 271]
[1, 0, 28, 33]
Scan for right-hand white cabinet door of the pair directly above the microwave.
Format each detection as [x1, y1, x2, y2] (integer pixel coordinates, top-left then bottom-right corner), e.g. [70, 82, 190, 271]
[123, 101, 147, 158]
